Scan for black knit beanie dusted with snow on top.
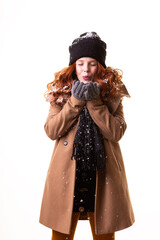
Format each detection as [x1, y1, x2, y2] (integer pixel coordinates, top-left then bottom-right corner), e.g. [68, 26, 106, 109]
[69, 32, 107, 68]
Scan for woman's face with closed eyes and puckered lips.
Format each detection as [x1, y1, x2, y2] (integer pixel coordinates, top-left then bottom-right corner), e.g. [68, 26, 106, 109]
[76, 57, 97, 84]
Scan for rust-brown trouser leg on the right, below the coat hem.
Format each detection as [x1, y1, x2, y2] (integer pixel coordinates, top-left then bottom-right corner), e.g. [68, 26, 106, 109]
[87, 212, 115, 240]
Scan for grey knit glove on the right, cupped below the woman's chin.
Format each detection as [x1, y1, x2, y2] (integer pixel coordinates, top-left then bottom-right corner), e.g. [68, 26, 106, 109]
[84, 82, 100, 101]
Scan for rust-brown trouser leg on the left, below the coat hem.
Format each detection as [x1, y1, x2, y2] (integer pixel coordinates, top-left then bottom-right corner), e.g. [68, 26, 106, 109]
[52, 212, 80, 240]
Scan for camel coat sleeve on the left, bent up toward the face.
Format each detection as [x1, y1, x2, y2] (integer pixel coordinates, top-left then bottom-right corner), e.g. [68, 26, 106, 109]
[44, 96, 85, 140]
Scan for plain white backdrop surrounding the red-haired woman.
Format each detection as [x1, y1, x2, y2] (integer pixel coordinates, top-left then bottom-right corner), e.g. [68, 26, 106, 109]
[0, 0, 160, 240]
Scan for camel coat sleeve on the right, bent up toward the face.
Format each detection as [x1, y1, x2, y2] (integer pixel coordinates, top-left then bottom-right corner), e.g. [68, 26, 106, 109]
[86, 97, 127, 142]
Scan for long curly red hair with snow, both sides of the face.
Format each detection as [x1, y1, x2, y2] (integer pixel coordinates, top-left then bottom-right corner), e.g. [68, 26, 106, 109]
[44, 62, 130, 105]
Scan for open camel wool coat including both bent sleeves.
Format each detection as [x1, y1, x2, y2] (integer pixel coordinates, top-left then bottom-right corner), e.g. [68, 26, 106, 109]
[39, 93, 134, 234]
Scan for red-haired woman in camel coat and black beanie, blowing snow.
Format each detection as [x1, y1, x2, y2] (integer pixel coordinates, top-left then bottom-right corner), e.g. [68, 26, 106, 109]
[40, 32, 134, 240]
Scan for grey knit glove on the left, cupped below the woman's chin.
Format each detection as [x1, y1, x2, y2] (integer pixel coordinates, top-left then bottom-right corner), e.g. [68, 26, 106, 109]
[71, 80, 86, 101]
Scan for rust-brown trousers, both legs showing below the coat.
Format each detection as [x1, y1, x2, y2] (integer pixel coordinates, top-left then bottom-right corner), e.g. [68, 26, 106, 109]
[52, 212, 115, 240]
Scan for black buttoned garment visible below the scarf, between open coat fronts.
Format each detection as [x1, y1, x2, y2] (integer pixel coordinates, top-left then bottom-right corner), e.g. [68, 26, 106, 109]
[73, 162, 96, 213]
